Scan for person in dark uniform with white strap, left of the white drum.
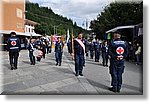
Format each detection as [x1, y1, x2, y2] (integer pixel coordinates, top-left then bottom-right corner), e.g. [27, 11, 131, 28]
[28, 39, 35, 65]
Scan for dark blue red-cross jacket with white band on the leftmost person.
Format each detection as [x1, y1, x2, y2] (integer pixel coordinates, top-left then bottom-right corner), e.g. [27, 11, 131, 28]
[7, 36, 21, 51]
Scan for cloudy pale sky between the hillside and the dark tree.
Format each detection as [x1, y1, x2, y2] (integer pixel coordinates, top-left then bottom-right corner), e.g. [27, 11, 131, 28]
[30, 0, 110, 28]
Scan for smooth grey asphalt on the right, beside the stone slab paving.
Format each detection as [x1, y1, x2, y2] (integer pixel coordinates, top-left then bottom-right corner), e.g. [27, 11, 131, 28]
[65, 53, 143, 95]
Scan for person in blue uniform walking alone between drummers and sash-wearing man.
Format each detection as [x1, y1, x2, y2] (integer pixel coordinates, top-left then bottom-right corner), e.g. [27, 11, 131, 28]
[55, 37, 64, 66]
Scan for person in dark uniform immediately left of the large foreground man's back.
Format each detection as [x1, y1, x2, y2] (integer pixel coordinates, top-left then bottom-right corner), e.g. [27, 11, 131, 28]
[102, 41, 108, 67]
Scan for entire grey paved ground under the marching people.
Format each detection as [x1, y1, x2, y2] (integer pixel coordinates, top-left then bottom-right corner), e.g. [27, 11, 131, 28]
[0, 49, 142, 95]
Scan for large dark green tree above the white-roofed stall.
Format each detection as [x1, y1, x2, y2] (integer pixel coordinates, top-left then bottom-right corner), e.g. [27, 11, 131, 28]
[90, 2, 143, 39]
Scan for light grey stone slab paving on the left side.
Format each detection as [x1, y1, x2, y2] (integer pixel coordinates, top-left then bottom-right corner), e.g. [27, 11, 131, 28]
[1, 47, 98, 95]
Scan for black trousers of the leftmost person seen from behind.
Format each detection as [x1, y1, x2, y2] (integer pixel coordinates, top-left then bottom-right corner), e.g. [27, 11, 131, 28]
[9, 51, 19, 68]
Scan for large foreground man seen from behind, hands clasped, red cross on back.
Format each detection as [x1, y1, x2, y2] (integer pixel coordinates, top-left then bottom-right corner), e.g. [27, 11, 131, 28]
[108, 32, 127, 92]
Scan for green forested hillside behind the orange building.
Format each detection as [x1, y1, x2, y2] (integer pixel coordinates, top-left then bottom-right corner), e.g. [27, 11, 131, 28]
[26, 2, 85, 35]
